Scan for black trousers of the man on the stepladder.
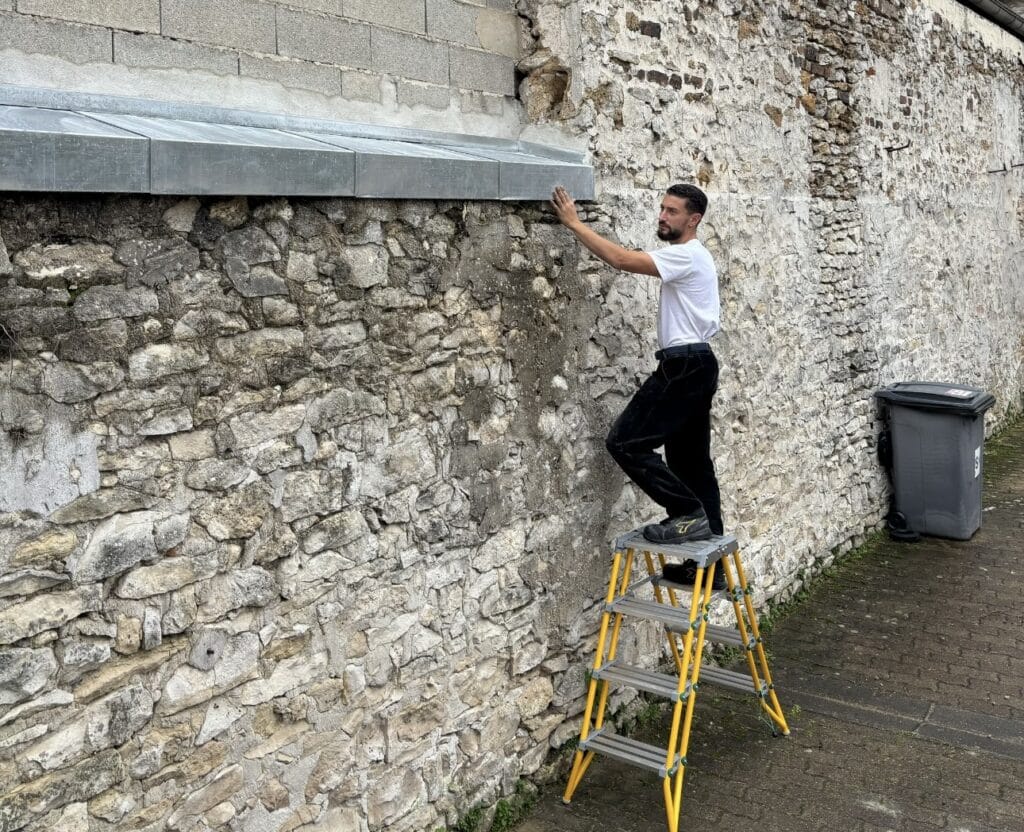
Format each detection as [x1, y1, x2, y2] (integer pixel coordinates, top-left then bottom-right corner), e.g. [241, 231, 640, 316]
[606, 348, 723, 535]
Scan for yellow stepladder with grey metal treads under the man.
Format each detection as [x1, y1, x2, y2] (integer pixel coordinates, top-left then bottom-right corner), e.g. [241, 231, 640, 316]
[562, 531, 790, 832]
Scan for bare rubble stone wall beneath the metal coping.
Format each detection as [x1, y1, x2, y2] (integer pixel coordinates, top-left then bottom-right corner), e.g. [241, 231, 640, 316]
[0, 198, 621, 830]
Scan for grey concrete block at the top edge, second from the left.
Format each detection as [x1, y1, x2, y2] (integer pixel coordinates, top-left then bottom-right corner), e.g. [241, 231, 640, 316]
[161, 0, 276, 53]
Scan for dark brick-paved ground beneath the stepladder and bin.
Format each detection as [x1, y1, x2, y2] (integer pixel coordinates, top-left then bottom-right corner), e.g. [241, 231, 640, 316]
[516, 421, 1024, 832]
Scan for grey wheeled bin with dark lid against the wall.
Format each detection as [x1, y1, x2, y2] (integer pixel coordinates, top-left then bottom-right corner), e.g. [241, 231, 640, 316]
[876, 381, 995, 540]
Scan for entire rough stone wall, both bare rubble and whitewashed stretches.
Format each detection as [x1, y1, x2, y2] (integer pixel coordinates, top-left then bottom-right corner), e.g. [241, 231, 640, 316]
[0, 0, 1024, 832]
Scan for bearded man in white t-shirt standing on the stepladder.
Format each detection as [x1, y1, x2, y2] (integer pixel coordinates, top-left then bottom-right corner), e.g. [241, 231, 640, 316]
[552, 184, 724, 588]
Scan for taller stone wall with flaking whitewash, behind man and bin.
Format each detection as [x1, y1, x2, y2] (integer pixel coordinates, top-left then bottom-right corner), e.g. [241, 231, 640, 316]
[520, 0, 1024, 596]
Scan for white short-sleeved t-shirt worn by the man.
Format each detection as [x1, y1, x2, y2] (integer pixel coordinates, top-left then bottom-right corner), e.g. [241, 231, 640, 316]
[647, 240, 719, 349]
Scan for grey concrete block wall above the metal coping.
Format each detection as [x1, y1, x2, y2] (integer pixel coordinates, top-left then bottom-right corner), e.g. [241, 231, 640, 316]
[0, 0, 520, 128]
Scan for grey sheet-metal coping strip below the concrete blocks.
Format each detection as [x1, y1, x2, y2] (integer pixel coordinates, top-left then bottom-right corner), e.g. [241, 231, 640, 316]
[0, 98, 594, 201]
